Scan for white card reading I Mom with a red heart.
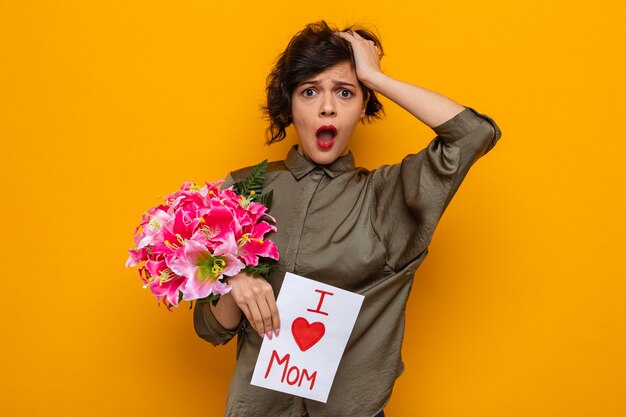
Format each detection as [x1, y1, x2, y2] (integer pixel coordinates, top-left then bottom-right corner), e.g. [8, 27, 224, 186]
[251, 272, 364, 402]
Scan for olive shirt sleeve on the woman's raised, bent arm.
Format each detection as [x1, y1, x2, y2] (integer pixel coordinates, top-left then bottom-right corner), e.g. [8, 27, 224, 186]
[371, 107, 501, 271]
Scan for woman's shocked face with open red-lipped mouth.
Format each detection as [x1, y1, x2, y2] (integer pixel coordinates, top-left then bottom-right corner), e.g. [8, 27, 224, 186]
[291, 61, 366, 165]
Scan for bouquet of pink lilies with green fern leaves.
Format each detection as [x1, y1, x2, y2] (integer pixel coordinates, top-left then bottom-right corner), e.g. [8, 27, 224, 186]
[126, 160, 279, 311]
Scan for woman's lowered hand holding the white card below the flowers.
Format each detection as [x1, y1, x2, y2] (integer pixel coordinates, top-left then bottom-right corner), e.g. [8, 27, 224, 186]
[228, 272, 280, 339]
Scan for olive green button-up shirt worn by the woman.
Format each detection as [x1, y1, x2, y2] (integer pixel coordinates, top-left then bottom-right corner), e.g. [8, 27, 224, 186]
[194, 108, 501, 417]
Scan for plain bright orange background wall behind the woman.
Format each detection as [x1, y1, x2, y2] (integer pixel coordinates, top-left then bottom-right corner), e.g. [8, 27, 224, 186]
[0, 0, 626, 417]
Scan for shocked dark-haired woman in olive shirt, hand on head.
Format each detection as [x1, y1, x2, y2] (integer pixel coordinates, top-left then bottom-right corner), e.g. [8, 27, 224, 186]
[194, 22, 500, 417]
